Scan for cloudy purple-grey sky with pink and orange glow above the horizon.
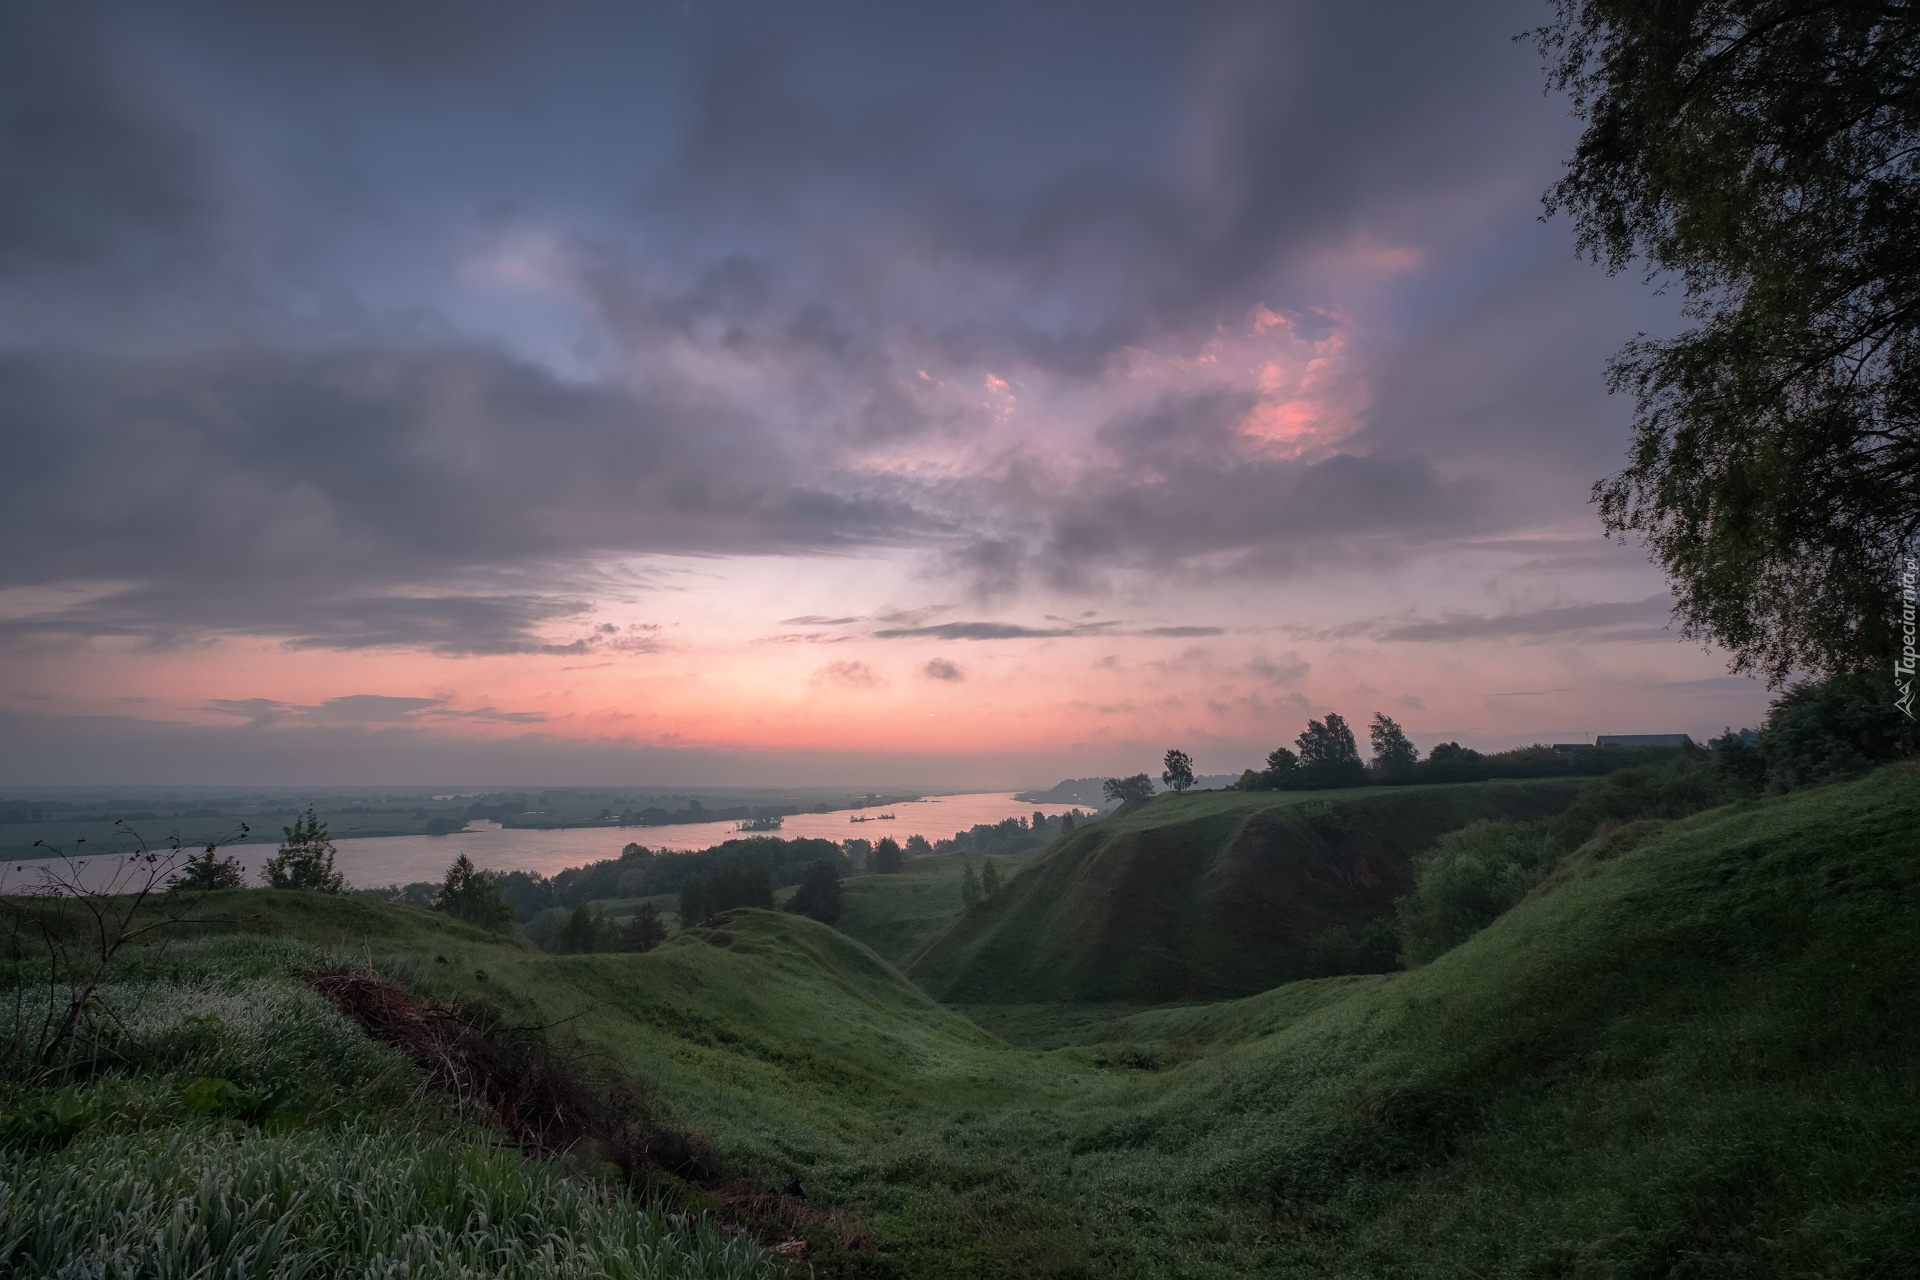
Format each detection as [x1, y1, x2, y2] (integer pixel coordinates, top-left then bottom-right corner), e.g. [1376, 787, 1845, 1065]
[0, 0, 1766, 787]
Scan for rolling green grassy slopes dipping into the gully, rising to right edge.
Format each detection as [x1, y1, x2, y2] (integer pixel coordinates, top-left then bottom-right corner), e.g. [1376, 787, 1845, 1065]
[0, 766, 1920, 1280]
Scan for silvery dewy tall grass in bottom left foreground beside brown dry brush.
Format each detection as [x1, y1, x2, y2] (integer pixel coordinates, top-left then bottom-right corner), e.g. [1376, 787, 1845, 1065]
[0, 936, 783, 1280]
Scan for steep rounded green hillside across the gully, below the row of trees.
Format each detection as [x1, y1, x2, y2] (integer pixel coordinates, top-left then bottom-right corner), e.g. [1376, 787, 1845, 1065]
[908, 779, 1578, 1004]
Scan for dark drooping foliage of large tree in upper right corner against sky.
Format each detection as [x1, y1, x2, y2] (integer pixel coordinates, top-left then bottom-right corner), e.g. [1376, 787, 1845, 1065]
[1536, 0, 1920, 687]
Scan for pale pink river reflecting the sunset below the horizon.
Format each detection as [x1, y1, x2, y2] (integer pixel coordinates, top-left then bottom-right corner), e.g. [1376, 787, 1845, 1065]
[0, 791, 1098, 892]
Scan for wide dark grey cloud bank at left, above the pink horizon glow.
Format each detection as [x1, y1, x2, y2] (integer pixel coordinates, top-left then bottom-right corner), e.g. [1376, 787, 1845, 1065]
[0, 347, 920, 652]
